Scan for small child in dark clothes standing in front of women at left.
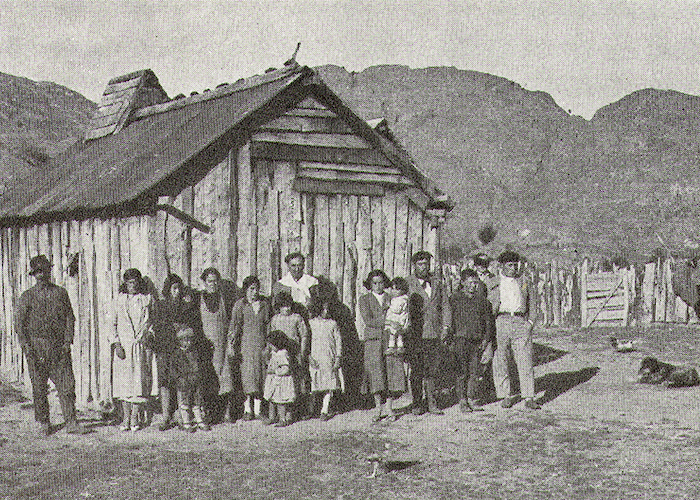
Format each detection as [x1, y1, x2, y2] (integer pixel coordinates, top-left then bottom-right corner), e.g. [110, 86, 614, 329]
[170, 323, 211, 432]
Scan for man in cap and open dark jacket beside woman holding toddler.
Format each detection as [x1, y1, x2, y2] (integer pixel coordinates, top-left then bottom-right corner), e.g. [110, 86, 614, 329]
[404, 251, 451, 415]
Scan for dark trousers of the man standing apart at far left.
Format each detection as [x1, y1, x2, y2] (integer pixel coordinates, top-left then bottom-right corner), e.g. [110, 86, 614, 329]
[26, 338, 76, 424]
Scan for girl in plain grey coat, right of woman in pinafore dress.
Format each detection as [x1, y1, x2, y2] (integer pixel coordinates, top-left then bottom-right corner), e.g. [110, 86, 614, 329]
[229, 276, 270, 420]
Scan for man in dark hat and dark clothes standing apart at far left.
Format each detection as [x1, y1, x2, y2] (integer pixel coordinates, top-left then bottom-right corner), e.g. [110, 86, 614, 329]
[16, 255, 85, 435]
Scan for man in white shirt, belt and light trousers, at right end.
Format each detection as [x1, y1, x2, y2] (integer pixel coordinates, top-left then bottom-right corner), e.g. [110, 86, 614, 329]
[493, 250, 541, 410]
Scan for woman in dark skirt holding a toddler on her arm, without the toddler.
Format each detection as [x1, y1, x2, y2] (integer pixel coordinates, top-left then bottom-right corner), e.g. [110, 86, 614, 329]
[357, 269, 406, 422]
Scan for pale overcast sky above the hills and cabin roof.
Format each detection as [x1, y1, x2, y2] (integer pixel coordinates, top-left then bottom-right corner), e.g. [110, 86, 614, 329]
[0, 0, 700, 118]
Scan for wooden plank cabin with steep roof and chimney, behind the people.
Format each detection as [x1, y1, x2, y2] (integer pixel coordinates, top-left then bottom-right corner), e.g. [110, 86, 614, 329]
[0, 63, 453, 407]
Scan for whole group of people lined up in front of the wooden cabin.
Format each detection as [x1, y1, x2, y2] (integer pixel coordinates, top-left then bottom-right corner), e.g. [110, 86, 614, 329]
[17, 247, 539, 434]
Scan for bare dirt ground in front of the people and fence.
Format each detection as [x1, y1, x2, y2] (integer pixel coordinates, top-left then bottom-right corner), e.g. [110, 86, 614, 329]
[0, 327, 700, 499]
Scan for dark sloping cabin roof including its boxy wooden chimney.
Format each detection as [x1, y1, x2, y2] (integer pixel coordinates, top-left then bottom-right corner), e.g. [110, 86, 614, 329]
[0, 64, 452, 225]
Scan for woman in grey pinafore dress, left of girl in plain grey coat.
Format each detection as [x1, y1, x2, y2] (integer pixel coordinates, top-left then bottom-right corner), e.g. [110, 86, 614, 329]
[199, 267, 235, 422]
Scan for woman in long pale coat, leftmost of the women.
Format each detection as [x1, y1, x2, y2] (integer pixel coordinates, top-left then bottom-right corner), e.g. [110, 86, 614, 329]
[113, 269, 153, 431]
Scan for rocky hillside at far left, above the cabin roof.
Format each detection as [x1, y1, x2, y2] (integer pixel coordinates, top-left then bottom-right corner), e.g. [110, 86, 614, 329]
[0, 73, 96, 193]
